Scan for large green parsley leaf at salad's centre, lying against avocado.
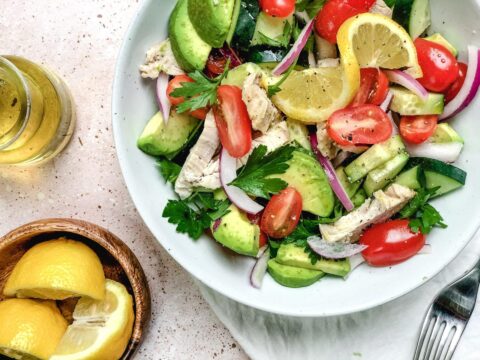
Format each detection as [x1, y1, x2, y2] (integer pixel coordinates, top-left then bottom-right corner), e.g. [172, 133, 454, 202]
[229, 145, 295, 199]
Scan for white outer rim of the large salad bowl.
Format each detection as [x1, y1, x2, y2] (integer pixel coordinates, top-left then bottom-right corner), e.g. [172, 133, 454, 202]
[111, 0, 480, 318]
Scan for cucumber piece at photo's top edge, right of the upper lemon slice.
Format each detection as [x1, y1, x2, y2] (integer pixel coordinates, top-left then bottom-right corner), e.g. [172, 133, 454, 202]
[393, 0, 432, 40]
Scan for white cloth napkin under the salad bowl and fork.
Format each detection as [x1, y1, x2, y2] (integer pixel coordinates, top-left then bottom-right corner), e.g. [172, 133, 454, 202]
[199, 233, 480, 360]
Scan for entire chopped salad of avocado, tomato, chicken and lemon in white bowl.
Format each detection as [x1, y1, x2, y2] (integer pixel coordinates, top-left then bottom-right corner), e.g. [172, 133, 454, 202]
[138, 0, 480, 288]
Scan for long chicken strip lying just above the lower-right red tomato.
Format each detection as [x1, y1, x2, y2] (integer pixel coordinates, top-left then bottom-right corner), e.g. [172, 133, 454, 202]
[320, 184, 415, 243]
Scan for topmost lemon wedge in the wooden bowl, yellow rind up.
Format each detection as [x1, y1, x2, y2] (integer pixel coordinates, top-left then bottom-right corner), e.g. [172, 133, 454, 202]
[3, 238, 105, 300]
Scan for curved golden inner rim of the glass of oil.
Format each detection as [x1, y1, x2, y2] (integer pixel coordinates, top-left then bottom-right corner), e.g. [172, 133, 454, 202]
[0, 55, 32, 150]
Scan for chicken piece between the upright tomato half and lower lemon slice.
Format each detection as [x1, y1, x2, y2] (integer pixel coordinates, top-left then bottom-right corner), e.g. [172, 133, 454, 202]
[242, 74, 281, 134]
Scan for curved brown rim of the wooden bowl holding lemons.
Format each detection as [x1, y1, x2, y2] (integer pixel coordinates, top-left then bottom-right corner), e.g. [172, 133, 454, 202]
[0, 218, 151, 360]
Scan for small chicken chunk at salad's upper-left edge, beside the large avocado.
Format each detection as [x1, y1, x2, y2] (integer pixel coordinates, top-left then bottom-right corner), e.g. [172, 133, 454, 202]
[140, 39, 184, 79]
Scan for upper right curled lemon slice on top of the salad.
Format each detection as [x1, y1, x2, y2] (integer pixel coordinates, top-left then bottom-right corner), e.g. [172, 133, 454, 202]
[337, 13, 422, 78]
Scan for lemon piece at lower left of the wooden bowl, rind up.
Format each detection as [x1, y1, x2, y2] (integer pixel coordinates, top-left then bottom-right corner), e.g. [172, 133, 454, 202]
[0, 299, 68, 360]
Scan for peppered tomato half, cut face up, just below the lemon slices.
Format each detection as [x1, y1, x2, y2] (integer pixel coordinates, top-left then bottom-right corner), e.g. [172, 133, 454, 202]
[327, 105, 393, 146]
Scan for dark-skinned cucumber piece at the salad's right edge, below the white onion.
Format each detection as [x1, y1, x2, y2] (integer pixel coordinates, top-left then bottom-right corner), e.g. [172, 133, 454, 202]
[410, 158, 467, 197]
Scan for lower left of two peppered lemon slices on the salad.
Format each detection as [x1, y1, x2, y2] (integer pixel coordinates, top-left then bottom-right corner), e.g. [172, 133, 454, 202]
[272, 65, 360, 124]
